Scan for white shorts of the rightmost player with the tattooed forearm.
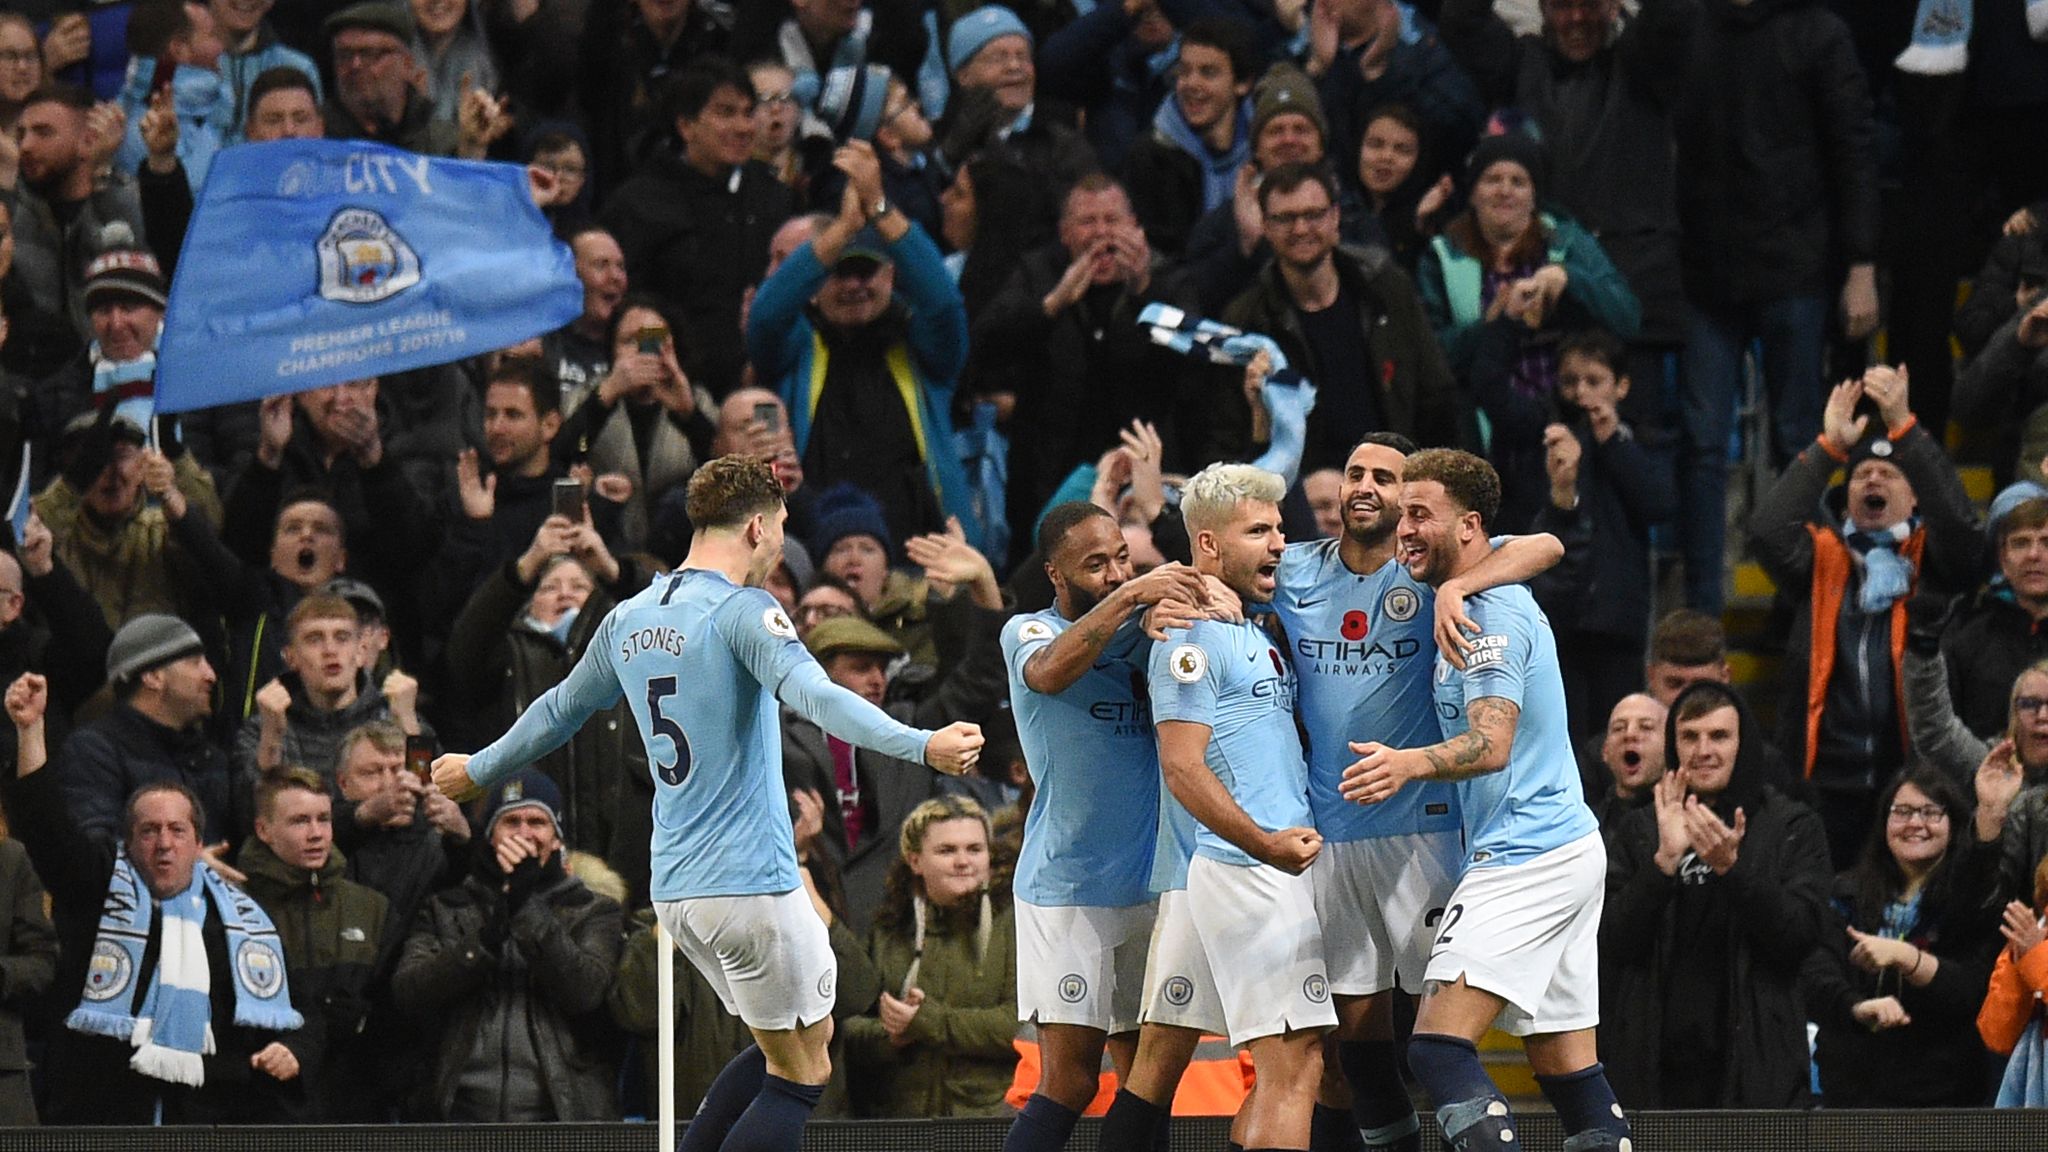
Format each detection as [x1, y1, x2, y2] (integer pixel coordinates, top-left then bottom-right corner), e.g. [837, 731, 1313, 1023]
[1425, 832, 1608, 1035]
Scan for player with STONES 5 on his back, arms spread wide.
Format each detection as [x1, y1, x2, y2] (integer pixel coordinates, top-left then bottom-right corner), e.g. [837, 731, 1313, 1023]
[434, 455, 981, 1152]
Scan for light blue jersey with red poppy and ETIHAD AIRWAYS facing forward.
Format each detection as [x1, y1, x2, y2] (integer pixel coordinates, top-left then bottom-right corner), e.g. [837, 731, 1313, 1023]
[1272, 539, 1458, 840]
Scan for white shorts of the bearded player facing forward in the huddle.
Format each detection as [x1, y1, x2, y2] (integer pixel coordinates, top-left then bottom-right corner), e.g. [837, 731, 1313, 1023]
[1309, 830, 1464, 996]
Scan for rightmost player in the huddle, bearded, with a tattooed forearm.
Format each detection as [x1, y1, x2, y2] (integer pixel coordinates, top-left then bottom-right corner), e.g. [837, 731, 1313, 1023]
[1343, 449, 1628, 1152]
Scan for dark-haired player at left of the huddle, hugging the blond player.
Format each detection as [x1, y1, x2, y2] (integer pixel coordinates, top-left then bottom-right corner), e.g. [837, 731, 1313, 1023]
[1004, 500, 1204, 1152]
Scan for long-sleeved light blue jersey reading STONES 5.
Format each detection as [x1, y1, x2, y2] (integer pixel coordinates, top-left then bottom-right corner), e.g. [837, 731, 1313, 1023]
[469, 568, 928, 900]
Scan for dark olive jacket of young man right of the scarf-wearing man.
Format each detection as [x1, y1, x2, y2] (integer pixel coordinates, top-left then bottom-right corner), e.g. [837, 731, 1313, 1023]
[236, 836, 389, 1123]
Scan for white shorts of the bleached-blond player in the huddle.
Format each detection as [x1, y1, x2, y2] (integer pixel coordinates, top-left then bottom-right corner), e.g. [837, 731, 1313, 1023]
[1188, 855, 1337, 1045]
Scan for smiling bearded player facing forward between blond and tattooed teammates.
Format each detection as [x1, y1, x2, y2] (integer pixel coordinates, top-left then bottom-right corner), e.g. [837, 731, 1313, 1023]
[1274, 433, 1565, 1150]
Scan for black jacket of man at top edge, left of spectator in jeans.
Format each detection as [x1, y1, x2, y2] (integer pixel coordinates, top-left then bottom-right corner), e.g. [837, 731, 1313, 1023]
[1438, 0, 1700, 344]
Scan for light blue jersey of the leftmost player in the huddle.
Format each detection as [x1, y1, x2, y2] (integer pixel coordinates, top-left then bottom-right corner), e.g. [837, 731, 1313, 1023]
[1004, 607, 1161, 908]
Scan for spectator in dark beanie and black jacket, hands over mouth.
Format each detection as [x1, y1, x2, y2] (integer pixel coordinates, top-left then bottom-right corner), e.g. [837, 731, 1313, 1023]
[391, 769, 625, 1123]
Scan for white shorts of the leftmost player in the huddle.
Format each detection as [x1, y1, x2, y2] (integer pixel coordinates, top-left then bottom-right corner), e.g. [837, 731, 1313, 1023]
[1016, 900, 1157, 1035]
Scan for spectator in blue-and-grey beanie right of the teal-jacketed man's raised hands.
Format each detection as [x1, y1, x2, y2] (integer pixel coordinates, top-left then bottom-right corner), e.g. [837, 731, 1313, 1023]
[811, 64, 944, 236]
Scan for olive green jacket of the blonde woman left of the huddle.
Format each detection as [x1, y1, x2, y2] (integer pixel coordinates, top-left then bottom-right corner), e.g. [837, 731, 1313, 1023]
[846, 892, 1018, 1119]
